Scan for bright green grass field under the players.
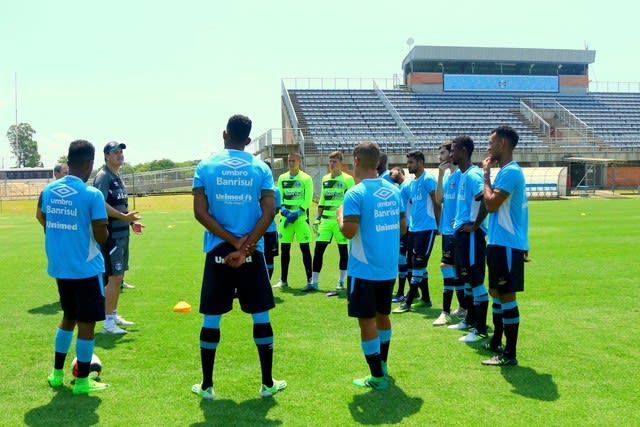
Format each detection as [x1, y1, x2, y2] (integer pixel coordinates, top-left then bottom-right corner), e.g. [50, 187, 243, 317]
[0, 196, 640, 426]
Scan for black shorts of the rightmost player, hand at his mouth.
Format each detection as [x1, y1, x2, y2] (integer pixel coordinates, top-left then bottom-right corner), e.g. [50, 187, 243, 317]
[487, 245, 526, 294]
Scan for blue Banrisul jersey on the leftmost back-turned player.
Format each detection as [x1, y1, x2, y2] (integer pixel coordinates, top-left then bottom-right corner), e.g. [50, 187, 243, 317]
[41, 175, 107, 279]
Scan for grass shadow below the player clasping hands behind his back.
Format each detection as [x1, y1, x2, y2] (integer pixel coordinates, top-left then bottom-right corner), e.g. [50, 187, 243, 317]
[191, 398, 282, 427]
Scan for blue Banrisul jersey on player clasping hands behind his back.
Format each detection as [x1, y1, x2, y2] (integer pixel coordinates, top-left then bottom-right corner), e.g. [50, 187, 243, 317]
[193, 149, 274, 252]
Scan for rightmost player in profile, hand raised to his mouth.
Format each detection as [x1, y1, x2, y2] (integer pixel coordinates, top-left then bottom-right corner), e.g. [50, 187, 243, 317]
[482, 126, 529, 366]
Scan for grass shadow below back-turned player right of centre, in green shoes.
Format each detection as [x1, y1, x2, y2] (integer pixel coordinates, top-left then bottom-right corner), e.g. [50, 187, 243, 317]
[349, 381, 424, 425]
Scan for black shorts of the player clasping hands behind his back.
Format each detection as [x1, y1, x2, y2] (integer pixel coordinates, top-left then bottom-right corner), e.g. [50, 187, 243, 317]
[200, 242, 275, 314]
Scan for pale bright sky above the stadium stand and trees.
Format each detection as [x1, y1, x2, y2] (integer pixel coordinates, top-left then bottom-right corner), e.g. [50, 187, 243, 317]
[0, 0, 640, 167]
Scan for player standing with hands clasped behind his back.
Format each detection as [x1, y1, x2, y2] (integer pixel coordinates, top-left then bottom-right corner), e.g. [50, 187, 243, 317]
[191, 115, 287, 400]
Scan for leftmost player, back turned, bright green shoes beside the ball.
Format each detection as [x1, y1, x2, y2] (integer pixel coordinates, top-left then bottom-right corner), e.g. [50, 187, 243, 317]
[42, 140, 109, 394]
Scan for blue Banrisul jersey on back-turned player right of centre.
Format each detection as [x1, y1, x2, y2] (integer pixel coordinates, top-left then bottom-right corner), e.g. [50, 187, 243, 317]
[343, 178, 404, 280]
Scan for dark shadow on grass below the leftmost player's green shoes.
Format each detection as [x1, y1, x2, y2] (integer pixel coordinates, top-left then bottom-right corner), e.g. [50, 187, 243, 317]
[24, 388, 102, 427]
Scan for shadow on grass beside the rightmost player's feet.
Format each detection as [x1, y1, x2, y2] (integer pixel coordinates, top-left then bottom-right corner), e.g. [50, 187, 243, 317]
[500, 366, 560, 402]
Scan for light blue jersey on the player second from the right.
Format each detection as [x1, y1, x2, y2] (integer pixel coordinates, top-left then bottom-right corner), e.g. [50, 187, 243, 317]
[453, 165, 487, 233]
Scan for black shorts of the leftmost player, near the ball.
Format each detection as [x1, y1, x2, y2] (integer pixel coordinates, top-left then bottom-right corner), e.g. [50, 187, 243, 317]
[56, 275, 104, 323]
